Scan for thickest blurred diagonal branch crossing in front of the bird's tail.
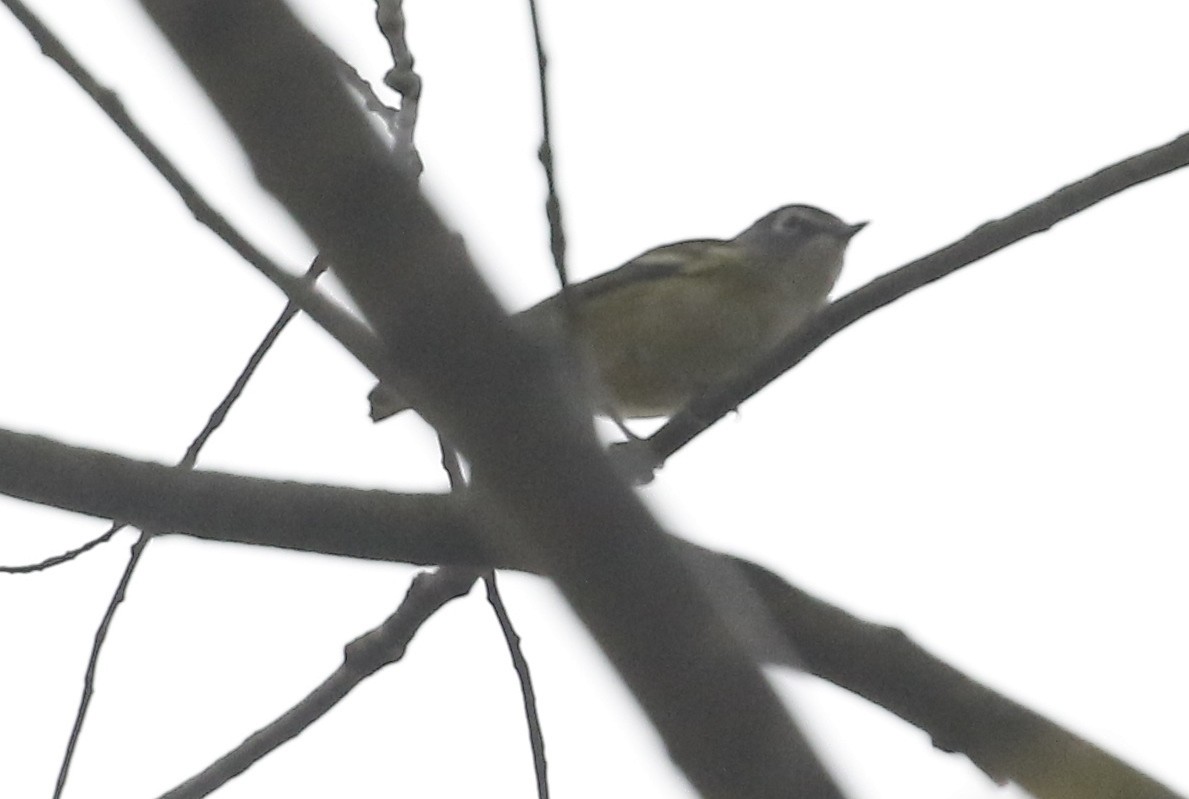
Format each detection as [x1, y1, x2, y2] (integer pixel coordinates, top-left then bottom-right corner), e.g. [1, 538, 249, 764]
[134, 0, 839, 797]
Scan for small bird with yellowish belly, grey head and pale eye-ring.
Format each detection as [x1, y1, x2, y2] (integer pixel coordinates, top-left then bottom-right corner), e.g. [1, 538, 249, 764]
[369, 205, 867, 427]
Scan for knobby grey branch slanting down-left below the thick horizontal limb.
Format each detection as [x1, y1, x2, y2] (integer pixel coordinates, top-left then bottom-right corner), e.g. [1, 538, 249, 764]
[161, 568, 478, 799]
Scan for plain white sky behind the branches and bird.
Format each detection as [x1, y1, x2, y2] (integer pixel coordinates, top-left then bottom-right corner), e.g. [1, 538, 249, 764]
[0, 0, 1189, 799]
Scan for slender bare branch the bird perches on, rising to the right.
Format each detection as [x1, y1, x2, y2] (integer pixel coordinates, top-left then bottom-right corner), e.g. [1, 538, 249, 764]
[634, 133, 1189, 467]
